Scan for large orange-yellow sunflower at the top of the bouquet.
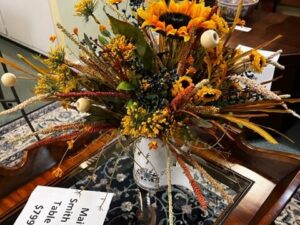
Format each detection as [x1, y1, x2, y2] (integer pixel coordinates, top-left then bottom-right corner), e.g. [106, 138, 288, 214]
[138, 0, 216, 41]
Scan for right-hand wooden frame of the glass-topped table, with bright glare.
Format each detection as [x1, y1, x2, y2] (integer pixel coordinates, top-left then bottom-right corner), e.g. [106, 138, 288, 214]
[195, 136, 300, 225]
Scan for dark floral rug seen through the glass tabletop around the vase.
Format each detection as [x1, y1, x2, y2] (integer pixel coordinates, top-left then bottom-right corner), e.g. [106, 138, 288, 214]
[71, 155, 237, 225]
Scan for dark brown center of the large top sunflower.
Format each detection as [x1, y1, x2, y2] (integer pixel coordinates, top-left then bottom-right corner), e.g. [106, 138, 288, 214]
[159, 13, 191, 29]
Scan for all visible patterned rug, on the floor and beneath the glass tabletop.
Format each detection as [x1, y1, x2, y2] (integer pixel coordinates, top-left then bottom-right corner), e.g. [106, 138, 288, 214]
[0, 103, 300, 225]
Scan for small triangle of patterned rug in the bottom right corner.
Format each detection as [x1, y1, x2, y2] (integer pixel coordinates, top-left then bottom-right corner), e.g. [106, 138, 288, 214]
[275, 187, 300, 225]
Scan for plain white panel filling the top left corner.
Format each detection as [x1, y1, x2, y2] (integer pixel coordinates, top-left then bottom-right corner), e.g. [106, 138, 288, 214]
[0, 0, 55, 53]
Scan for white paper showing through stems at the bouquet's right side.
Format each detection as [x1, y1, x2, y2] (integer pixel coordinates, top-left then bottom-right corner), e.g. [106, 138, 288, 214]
[237, 45, 279, 90]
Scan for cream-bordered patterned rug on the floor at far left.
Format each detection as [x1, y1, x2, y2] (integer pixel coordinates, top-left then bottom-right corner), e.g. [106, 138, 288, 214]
[0, 102, 84, 167]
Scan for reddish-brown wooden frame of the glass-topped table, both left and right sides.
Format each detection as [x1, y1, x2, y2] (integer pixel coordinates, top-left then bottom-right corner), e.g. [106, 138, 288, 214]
[0, 131, 300, 225]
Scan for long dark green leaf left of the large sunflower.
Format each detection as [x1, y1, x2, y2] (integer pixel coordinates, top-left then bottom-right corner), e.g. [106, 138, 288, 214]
[107, 14, 154, 71]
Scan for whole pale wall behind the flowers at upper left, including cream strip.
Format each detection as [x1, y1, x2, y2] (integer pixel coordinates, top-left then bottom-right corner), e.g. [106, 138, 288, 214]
[0, 0, 125, 55]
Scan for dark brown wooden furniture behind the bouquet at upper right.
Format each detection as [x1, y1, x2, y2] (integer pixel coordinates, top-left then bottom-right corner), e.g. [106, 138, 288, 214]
[230, 11, 300, 132]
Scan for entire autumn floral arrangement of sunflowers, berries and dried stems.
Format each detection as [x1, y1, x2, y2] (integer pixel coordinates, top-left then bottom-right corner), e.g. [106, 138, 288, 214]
[0, 0, 299, 220]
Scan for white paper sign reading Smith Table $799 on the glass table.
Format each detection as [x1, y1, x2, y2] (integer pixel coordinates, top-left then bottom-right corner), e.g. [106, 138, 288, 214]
[14, 186, 113, 225]
